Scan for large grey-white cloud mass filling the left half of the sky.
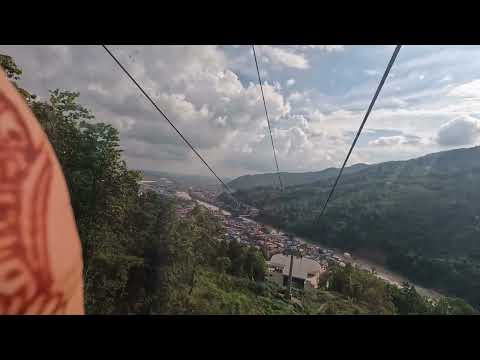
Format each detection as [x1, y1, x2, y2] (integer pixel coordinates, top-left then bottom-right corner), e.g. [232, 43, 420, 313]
[0, 46, 298, 174]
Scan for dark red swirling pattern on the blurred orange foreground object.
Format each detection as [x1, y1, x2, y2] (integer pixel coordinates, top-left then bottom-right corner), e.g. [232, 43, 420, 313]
[0, 92, 66, 314]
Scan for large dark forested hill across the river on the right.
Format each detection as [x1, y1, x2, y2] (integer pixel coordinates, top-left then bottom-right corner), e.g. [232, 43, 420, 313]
[238, 147, 480, 307]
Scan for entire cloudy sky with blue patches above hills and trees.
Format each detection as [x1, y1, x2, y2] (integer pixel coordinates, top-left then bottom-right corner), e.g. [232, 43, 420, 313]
[0, 45, 480, 177]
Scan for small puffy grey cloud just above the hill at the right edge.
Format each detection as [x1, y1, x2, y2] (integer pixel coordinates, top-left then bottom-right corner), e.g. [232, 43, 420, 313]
[437, 116, 480, 146]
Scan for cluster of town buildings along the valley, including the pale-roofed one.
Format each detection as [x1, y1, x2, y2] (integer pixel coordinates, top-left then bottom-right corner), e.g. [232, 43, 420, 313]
[142, 178, 358, 289]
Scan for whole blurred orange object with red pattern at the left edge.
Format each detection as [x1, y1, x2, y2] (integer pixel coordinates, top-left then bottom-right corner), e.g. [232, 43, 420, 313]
[0, 69, 84, 314]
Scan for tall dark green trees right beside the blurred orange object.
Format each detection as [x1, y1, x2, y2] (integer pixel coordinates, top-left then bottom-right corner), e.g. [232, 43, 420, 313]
[30, 90, 143, 313]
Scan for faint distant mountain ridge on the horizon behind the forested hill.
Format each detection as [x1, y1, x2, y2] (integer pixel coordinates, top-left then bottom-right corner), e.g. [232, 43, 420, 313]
[228, 164, 369, 190]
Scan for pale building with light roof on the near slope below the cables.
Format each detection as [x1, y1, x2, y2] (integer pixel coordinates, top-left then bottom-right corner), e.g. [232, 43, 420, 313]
[267, 254, 327, 289]
